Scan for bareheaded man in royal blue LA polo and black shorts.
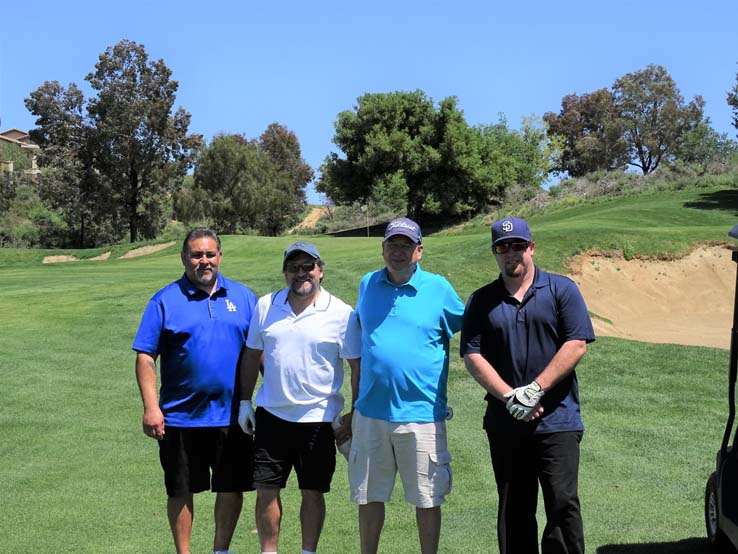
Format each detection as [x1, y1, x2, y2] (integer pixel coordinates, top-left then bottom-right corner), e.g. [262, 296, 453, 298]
[133, 229, 257, 554]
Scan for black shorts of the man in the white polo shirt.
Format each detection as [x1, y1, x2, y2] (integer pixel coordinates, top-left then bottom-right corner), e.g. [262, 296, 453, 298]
[254, 408, 336, 492]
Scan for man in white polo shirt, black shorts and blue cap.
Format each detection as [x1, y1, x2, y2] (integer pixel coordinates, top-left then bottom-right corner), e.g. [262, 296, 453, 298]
[238, 242, 361, 554]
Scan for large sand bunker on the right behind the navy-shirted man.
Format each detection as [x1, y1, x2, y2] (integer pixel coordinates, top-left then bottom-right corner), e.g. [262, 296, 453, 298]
[571, 246, 736, 349]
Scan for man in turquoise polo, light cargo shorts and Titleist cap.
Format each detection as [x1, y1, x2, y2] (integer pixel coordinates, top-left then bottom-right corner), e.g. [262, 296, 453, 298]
[349, 218, 464, 554]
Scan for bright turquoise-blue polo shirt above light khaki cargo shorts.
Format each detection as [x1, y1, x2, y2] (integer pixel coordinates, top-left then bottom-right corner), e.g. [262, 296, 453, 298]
[356, 264, 464, 423]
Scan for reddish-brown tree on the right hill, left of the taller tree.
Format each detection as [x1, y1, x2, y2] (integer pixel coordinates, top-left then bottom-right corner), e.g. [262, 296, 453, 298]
[543, 88, 628, 177]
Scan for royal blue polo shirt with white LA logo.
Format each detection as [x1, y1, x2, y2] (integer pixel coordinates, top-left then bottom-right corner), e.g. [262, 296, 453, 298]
[133, 274, 257, 427]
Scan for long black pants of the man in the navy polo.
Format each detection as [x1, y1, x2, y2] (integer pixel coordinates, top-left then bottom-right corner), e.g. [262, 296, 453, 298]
[487, 431, 584, 554]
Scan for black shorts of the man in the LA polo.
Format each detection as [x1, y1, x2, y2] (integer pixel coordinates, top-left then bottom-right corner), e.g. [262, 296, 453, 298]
[159, 425, 254, 496]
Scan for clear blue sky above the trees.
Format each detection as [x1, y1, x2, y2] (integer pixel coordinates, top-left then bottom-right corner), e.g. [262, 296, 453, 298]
[0, 0, 738, 201]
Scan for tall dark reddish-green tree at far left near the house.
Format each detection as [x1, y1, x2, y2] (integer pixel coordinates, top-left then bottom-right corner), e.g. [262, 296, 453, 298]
[25, 40, 202, 246]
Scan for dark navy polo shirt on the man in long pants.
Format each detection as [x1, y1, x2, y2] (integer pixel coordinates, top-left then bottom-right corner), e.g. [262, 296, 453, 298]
[461, 267, 595, 433]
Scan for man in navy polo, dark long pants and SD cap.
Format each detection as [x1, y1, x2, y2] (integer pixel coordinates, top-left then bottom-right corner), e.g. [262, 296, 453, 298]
[461, 217, 595, 554]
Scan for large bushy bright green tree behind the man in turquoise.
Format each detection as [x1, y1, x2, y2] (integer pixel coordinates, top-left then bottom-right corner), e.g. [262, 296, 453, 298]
[316, 91, 545, 219]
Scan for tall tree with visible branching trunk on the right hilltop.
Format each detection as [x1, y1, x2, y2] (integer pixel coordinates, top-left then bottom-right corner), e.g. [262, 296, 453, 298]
[612, 64, 704, 175]
